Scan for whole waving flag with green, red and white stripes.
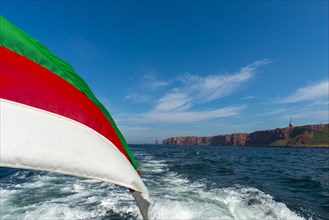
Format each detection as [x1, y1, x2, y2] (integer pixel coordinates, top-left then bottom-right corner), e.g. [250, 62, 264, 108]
[0, 16, 149, 218]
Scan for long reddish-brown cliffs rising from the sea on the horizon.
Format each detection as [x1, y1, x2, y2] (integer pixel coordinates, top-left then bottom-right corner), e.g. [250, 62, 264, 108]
[162, 124, 329, 146]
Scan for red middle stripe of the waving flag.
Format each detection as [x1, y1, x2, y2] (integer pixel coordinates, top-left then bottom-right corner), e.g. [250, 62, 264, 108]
[0, 46, 130, 161]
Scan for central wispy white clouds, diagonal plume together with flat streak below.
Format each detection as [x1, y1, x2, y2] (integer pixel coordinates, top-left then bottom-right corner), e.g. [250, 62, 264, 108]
[122, 59, 269, 124]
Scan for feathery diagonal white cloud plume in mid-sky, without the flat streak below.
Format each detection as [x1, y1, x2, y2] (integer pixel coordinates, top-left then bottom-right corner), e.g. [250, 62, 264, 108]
[154, 59, 269, 111]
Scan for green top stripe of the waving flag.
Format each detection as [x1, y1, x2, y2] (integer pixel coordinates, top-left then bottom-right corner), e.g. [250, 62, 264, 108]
[0, 16, 138, 170]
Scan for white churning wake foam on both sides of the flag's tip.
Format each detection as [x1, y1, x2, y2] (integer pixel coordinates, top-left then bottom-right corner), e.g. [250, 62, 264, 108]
[0, 156, 303, 220]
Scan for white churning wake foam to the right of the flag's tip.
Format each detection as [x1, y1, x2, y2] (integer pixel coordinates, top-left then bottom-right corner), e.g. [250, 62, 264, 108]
[143, 155, 303, 220]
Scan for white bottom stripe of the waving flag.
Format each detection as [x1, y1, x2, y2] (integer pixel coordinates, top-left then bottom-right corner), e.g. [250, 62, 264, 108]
[0, 99, 149, 201]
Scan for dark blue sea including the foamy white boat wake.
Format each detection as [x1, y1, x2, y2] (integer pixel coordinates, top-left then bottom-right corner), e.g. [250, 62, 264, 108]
[0, 145, 329, 220]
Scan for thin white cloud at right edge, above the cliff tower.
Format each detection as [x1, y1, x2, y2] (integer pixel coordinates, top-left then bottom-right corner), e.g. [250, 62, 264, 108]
[279, 81, 329, 103]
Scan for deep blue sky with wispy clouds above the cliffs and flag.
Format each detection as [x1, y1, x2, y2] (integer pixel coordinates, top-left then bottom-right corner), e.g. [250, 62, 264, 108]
[0, 0, 329, 143]
